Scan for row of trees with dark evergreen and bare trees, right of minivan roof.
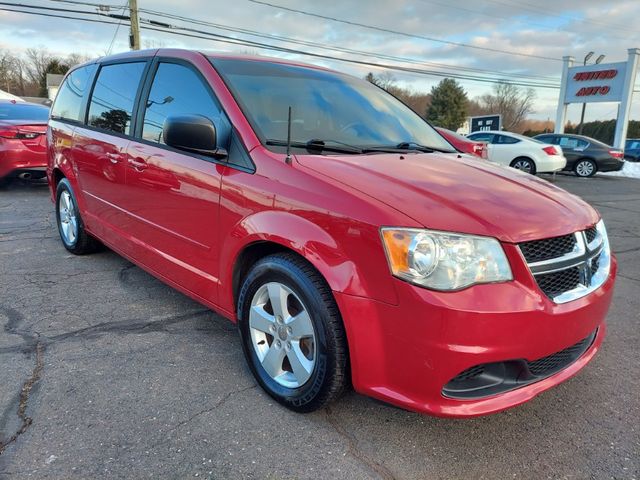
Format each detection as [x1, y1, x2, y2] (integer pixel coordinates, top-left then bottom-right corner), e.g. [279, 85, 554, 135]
[365, 72, 536, 132]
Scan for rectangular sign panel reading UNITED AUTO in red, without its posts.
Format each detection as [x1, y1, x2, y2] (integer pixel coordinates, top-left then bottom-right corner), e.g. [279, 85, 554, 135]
[564, 62, 627, 103]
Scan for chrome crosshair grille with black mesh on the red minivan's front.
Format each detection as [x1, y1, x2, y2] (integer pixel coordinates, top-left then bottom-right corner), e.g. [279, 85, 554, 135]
[518, 225, 610, 303]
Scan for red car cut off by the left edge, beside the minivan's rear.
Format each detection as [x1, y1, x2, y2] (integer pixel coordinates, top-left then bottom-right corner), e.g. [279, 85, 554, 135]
[0, 100, 49, 180]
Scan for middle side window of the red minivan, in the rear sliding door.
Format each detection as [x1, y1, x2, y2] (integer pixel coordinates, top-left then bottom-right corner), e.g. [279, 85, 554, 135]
[89, 62, 146, 134]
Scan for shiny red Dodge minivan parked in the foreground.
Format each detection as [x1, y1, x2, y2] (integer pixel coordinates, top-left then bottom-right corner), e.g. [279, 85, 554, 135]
[47, 49, 616, 417]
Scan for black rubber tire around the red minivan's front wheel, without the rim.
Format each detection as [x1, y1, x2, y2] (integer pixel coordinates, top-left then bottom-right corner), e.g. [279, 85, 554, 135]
[238, 253, 349, 413]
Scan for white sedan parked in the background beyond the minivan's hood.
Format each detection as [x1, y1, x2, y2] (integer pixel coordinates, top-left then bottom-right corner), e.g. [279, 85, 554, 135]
[467, 131, 567, 174]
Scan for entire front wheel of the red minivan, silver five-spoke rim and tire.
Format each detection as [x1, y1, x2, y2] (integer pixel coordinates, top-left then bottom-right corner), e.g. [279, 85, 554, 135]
[238, 253, 348, 412]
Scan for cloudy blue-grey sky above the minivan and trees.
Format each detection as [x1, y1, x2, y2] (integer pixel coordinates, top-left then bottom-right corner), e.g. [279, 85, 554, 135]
[0, 0, 640, 122]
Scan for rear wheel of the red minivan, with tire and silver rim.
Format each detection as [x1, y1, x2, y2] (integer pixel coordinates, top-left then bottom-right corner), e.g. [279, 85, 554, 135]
[56, 178, 100, 255]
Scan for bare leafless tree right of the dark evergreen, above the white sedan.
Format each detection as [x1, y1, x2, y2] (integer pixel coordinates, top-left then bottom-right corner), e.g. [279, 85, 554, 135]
[472, 83, 536, 131]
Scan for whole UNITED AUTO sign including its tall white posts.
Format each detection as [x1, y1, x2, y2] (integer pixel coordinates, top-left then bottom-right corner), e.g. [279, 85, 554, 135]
[554, 48, 640, 148]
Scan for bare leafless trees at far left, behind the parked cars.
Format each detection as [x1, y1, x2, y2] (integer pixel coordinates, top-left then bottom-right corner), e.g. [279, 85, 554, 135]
[0, 48, 89, 97]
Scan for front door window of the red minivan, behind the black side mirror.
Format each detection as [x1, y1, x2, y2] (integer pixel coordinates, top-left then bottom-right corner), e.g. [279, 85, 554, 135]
[142, 63, 231, 148]
